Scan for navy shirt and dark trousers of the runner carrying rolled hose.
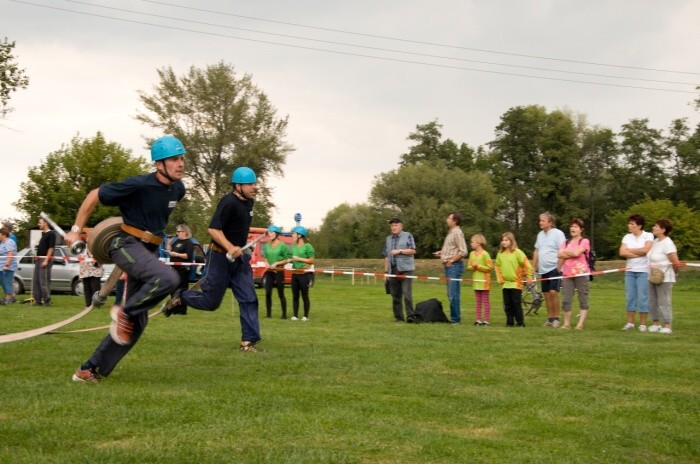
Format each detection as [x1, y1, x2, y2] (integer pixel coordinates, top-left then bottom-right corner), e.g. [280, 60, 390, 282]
[81, 173, 185, 377]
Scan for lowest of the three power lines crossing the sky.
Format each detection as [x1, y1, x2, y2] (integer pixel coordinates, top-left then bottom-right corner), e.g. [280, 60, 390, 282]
[10, 0, 695, 94]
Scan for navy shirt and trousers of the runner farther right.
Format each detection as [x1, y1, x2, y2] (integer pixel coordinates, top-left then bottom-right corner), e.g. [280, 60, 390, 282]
[180, 193, 260, 343]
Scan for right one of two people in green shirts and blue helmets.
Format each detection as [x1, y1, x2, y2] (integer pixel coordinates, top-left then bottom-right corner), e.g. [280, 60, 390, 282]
[287, 226, 316, 321]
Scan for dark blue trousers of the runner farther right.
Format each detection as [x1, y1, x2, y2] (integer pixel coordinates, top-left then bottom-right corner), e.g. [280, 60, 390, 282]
[180, 251, 260, 343]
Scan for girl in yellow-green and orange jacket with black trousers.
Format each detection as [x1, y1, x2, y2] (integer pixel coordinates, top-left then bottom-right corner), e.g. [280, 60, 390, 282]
[496, 232, 532, 327]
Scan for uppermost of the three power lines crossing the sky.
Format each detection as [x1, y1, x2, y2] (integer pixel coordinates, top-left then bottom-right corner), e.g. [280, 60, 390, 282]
[140, 0, 700, 75]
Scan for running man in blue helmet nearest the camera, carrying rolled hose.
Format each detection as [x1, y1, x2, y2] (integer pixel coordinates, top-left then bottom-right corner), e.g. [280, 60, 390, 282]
[66, 135, 185, 382]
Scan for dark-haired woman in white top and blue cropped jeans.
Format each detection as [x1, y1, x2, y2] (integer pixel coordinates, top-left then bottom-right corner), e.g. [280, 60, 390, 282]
[620, 214, 654, 332]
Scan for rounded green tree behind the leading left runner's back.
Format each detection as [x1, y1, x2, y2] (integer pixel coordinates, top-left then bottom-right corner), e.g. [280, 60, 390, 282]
[13, 132, 149, 226]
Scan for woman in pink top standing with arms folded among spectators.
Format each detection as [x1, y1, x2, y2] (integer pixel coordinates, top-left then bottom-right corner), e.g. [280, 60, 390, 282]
[557, 218, 591, 330]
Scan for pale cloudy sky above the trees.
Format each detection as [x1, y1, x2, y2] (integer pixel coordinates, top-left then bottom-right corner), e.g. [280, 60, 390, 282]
[0, 0, 700, 228]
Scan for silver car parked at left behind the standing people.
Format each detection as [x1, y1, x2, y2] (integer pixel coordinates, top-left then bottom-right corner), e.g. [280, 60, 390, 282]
[14, 246, 114, 295]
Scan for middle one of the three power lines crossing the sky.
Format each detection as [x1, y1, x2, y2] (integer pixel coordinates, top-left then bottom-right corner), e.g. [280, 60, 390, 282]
[58, 0, 697, 86]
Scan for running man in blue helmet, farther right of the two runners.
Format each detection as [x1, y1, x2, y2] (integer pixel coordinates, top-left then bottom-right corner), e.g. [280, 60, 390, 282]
[163, 167, 260, 351]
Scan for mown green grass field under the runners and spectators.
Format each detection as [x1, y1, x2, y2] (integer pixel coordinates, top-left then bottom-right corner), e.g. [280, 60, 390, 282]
[0, 263, 700, 463]
